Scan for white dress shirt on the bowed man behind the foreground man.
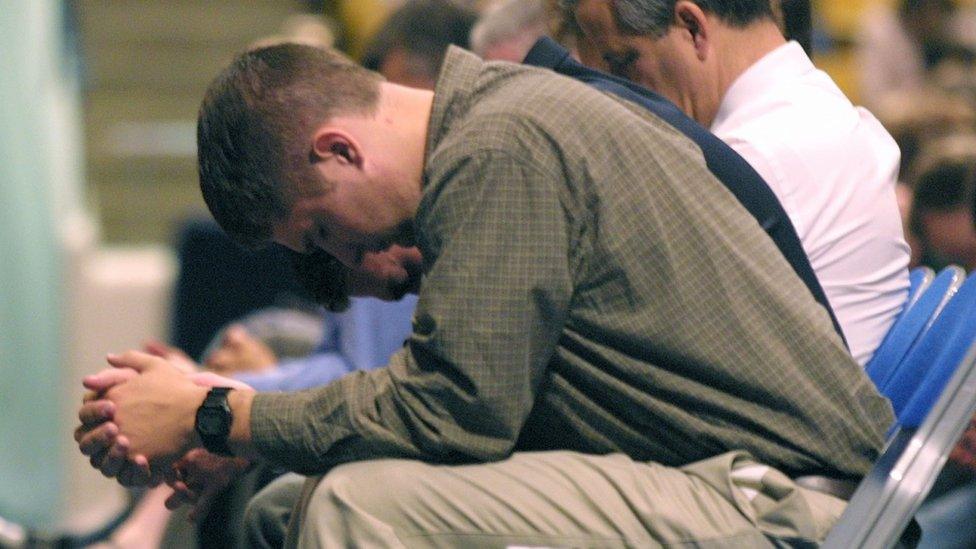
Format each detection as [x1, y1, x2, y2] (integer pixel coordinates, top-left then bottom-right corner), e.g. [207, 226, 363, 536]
[711, 42, 909, 365]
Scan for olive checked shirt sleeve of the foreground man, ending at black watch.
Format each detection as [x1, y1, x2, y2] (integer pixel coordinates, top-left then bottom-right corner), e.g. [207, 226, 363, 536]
[251, 151, 572, 473]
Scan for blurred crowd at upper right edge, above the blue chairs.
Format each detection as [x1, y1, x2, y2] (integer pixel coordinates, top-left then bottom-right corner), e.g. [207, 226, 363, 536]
[857, 0, 976, 270]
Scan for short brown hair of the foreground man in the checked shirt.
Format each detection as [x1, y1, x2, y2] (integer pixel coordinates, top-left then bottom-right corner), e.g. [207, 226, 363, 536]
[197, 44, 382, 247]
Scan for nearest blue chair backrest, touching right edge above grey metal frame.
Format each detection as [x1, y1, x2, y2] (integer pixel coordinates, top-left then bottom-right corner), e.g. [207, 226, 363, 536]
[881, 275, 976, 425]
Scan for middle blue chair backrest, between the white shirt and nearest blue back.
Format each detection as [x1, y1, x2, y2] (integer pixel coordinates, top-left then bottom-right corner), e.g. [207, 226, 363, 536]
[865, 265, 966, 390]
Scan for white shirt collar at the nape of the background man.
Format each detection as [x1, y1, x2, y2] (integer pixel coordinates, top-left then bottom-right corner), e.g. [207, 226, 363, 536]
[711, 40, 816, 130]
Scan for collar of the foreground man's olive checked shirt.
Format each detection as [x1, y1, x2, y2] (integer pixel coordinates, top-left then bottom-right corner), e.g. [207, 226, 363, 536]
[424, 46, 485, 184]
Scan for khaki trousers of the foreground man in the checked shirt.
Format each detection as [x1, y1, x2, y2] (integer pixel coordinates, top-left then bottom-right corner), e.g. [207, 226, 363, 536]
[278, 452, 845, 548]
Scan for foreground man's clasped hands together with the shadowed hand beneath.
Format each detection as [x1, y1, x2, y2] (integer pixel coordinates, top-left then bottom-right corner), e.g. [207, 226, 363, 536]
[74, 347, 253, 509]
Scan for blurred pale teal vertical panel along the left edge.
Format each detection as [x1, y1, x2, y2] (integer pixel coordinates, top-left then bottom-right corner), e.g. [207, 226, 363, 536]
[0, 0, 80, 528]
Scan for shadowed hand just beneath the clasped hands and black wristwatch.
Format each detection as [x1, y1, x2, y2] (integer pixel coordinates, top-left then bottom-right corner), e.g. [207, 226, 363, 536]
[166, 448, 250, 520]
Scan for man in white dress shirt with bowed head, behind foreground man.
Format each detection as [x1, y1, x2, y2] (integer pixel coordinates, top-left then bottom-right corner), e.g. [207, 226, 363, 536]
[562, 0, 909, 364]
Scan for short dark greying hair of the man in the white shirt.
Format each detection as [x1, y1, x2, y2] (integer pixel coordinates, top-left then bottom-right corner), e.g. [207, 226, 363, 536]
[561, 0, 775, 37]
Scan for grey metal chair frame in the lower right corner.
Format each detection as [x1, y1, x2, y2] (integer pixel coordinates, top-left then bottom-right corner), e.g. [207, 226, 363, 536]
[822, 336, 976, 549]
